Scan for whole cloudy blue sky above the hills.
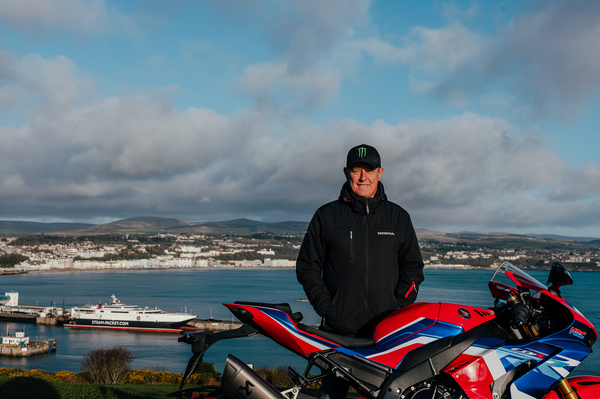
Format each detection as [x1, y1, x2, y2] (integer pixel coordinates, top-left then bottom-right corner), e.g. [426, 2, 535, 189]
[0, 0, 600, 237]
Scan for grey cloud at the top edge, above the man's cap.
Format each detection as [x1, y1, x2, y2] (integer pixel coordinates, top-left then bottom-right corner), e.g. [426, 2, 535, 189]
[230, 0, 370, 112]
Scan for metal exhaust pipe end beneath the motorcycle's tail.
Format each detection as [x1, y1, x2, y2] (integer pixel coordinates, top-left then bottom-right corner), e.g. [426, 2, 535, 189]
[221, 355, 287, 399]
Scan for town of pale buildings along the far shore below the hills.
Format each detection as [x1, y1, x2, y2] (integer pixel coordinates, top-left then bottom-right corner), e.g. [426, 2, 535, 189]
[0, 233, 600, 273]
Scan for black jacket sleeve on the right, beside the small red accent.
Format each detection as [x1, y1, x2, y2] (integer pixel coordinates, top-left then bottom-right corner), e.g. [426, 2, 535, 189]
[396, 217, 425, 307]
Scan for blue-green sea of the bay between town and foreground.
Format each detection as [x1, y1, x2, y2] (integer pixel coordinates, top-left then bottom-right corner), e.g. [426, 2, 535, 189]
[0, 268, 600, 375]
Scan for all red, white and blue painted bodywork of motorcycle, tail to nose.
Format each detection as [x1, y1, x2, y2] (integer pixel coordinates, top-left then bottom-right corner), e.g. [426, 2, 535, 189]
[226, 266, 596, 399]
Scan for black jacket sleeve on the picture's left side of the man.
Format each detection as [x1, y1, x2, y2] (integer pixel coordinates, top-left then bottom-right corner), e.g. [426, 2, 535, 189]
[296, 211, 332, 317]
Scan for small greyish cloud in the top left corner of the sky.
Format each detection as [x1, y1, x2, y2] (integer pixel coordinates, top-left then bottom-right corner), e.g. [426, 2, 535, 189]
[0, 0, 109, 33]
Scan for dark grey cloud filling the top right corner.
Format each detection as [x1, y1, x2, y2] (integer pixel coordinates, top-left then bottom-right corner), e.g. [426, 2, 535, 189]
[496, 1, 600, 121]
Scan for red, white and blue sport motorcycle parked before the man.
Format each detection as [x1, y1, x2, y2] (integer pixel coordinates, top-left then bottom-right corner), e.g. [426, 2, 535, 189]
[179, 262, 600, 399]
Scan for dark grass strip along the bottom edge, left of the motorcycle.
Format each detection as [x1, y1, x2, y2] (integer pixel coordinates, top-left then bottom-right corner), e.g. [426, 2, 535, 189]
[0, 377, 214, 399]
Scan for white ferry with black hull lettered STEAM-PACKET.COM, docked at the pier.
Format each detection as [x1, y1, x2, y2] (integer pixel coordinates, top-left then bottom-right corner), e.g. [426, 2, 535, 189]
[64, 294, 196, 332]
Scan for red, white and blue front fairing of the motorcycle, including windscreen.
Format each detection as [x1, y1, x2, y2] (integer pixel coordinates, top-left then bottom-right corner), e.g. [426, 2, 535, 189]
[443, 262, 597, 399]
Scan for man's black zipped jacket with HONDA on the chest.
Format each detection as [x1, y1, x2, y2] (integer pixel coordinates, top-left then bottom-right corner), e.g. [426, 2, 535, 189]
[296, 182, 424, 337]
